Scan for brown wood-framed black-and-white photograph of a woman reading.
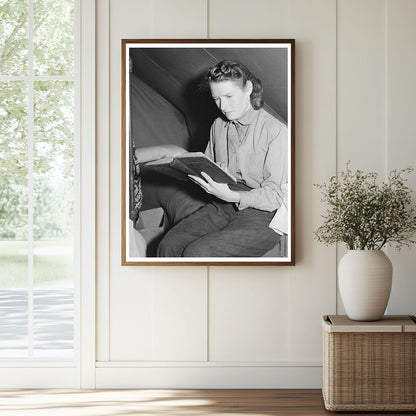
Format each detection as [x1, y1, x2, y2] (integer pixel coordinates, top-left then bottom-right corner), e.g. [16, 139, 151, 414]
[121, 39, 295, 266]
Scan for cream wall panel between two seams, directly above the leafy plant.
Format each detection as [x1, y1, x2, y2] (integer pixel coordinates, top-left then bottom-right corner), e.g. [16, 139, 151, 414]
[337, 0, 387, 172]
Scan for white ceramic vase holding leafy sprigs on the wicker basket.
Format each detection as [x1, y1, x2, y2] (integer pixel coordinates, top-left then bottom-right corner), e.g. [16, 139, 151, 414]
[338, 250, 393, 321]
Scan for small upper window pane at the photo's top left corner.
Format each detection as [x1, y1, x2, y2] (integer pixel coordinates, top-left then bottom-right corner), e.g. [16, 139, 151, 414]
[0, 0, 28, 75]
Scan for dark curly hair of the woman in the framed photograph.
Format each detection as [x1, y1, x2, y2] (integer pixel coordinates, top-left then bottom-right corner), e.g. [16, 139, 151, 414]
[205, 60, 264, 110]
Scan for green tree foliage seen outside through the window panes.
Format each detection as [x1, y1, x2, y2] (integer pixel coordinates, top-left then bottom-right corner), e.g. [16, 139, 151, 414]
[0, 0, 74, 239]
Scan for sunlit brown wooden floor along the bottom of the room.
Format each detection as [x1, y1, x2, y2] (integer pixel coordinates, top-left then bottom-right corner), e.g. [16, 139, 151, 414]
[0, 390, 415, 416]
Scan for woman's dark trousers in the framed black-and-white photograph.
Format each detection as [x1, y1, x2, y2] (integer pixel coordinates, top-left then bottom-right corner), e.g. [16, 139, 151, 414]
[157, 201, 280, 257]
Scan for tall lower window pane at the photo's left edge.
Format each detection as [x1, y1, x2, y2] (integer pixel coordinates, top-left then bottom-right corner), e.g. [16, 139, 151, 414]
[0, 81, 28, 359]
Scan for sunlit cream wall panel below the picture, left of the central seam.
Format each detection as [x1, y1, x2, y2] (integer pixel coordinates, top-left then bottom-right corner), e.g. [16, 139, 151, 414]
[110, 267, 207, 361]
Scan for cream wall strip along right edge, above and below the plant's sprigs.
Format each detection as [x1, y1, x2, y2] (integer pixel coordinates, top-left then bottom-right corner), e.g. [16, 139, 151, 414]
[386, 0, 416, 313]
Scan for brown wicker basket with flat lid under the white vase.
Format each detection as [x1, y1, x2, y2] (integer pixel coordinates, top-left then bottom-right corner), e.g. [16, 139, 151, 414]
[322, 315, 416, 411]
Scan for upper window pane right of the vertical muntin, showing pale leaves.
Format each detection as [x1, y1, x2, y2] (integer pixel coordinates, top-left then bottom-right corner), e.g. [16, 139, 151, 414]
[33, 0, 74, 75]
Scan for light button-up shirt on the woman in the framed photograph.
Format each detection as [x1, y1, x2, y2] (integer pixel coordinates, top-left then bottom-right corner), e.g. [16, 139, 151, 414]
[205, 106, 288, 211]
